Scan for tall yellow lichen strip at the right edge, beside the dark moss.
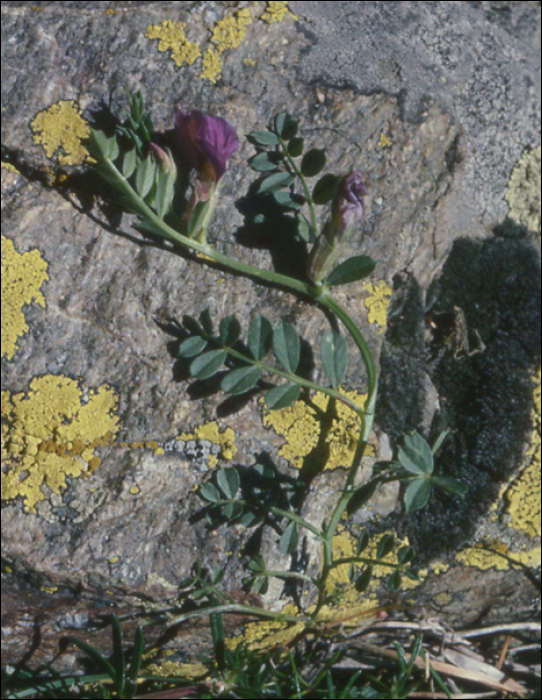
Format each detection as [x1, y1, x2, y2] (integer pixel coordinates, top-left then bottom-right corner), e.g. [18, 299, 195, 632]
[504, 367, 541, 537]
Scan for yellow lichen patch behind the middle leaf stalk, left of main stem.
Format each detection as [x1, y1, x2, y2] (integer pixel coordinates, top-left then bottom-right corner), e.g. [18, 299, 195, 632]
[263, 391, 373, 469]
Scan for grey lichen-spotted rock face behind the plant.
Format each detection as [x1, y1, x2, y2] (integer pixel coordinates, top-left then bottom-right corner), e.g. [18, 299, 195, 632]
[2, 1, 540, 668]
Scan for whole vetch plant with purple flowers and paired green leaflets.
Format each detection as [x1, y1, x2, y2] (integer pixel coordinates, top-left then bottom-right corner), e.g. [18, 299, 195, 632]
[89, 93, 465, 640]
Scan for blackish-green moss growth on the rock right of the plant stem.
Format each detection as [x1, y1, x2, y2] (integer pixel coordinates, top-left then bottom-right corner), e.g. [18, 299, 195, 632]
[379, 238, 541, 557]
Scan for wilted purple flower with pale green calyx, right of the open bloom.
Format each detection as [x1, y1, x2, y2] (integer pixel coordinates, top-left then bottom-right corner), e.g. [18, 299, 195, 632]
[308, 171, 369, 284]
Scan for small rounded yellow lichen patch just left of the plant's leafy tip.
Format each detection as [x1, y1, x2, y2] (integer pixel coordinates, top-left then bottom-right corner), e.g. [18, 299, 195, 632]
[30, 100, 90, 165]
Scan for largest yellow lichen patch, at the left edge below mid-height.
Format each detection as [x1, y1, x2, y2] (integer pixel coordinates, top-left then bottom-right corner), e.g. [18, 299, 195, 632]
[1, 375, 119, 513]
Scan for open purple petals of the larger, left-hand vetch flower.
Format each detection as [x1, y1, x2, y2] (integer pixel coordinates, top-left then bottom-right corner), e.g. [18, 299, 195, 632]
[175, 107, 239, 183]
